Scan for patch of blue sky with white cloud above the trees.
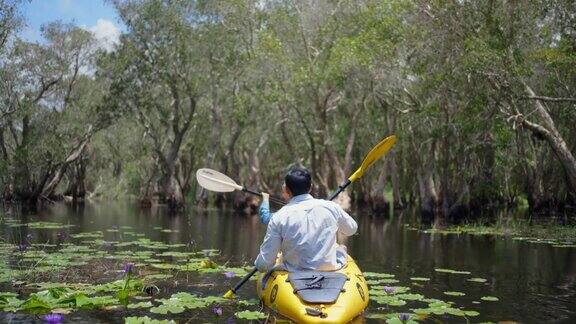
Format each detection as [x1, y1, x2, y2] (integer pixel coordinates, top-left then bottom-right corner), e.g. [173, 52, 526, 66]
[21, 0, 124, 48]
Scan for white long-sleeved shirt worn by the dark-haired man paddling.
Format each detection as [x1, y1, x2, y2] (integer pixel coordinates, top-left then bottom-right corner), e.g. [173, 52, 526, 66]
[254, 194, 358, 271]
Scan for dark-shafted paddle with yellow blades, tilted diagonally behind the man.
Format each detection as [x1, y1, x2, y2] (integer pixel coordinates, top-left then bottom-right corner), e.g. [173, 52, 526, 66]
[224, 135, 396, 298]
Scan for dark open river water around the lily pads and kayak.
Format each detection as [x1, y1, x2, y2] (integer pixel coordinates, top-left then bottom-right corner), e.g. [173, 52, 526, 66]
[0, 204, 576, 323]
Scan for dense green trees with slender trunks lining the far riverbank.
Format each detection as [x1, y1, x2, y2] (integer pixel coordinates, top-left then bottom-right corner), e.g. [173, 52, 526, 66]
[0, 0, 576, 219]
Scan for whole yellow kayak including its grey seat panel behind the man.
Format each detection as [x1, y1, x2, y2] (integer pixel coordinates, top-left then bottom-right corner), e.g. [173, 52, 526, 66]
[256, 257, 368, 323]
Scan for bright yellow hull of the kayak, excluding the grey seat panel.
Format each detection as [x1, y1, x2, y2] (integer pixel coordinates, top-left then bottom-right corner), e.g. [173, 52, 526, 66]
[256, 257, 369, 323]
